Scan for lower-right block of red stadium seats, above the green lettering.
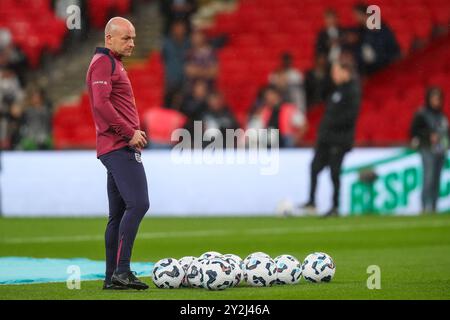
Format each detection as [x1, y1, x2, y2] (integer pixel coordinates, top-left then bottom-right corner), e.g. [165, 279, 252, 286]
[357, 33, 450, 145]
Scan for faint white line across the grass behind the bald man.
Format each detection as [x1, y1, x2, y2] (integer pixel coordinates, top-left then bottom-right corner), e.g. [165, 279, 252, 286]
[0, 221, 450, 244]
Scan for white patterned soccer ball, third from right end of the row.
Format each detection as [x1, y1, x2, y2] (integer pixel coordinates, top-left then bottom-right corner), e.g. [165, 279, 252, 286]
[245, 256, 277, 287]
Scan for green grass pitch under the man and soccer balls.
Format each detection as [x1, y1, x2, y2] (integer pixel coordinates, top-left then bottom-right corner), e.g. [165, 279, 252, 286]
[0, 214, 450, 300]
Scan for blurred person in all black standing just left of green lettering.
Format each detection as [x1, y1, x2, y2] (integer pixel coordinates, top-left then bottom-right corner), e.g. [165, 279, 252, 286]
[303, 62, 361, 217]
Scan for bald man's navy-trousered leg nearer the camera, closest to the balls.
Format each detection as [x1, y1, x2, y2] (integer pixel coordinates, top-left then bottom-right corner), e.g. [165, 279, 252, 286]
[101, 148, 149, 288]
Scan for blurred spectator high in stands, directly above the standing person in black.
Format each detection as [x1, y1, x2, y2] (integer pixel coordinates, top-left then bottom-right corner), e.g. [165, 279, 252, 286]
[316, 9, 344, 63]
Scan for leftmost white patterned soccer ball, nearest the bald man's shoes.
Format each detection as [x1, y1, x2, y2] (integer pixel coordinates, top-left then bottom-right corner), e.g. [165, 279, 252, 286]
[152, 258, 185, 289]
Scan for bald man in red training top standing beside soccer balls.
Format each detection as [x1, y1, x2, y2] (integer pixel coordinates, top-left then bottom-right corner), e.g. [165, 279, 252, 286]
[86, 17, 149, 290]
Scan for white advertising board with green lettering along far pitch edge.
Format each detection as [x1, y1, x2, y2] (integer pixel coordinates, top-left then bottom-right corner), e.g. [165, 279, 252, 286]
[0, 148, 450, 217]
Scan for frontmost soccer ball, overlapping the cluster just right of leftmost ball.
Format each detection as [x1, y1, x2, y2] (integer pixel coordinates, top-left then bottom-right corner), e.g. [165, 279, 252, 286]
[203, 258, 235, 290]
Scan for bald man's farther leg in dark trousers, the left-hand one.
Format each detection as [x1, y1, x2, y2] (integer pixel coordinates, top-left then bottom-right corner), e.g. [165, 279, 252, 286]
[105, 171, 125, 283]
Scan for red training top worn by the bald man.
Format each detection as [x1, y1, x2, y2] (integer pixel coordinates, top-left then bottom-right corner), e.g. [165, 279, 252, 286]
[86, 47, 139, 158]
